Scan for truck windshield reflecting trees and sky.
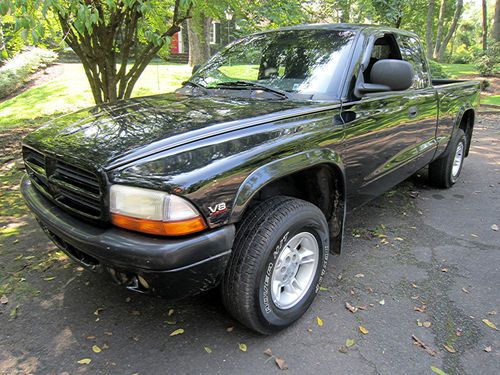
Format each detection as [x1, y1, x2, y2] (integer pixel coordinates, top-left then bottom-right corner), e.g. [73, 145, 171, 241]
[190, 29, 354, 96]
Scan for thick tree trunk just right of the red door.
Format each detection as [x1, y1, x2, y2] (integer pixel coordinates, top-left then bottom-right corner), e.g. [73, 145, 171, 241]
[187, 13, 212, 66]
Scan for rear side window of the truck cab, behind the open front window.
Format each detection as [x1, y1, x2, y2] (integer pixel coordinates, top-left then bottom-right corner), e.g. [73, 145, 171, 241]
[397, 35, 429, 89]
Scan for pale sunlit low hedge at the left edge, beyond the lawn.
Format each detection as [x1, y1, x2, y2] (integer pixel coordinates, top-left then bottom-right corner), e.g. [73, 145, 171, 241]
[0, 48, 57, 98]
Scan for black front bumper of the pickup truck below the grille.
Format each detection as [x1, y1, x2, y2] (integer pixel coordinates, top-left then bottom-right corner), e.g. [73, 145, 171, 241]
[21, 175, 235, 299]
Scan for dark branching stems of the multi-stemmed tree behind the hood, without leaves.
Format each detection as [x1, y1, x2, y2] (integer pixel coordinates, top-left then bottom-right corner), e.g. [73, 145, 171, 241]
[57, 0, 191, 104]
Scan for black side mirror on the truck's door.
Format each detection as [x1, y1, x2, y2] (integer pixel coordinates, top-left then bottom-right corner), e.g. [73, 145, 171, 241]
[356, 59, 414, 94]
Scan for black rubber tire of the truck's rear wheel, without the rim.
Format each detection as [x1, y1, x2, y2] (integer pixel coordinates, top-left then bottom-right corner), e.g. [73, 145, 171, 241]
[429, 129, 467, 189]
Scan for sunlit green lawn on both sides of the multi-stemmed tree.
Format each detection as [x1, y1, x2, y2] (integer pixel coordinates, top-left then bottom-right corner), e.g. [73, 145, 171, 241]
[0, 63, 191, 129]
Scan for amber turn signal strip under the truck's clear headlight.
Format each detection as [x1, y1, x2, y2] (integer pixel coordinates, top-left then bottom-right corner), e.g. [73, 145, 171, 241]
[111, 214, 207, 236]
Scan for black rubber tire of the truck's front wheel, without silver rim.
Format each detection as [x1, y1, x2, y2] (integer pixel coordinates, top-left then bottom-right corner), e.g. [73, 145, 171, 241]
[221, 196, 329, 334]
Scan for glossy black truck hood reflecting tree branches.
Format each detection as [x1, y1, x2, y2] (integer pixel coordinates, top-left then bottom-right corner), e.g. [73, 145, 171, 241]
[24, 93, 332, 169]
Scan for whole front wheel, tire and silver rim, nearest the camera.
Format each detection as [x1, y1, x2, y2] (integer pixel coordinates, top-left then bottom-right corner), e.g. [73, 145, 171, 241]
[221, 197, 329, 334]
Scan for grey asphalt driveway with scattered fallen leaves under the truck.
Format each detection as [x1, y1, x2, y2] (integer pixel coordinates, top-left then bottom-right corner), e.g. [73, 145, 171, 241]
[0, 115, 500, 374]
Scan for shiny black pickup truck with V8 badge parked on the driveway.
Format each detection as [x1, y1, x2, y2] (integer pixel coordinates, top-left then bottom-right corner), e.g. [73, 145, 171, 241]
[21, 24, 480, 333]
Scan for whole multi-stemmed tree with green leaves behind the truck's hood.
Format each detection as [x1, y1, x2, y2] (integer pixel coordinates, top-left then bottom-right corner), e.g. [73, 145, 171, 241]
[0, 0, 194, 104]
